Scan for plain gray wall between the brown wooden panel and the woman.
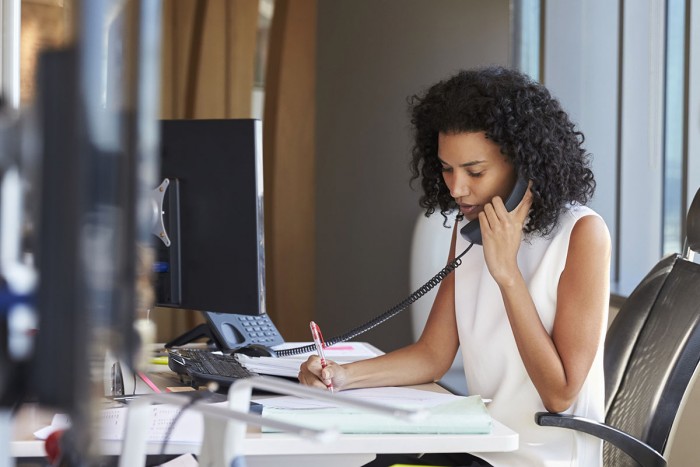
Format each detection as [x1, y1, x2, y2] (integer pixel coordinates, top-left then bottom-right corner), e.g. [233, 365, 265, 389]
[316, 0, 510, 350]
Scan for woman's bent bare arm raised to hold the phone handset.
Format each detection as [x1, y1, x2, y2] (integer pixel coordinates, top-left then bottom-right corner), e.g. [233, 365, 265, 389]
[484, 196, 610, 412]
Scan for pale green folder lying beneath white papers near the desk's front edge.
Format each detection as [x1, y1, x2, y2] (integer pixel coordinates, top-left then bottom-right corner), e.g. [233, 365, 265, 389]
[263, 396, 491, 434]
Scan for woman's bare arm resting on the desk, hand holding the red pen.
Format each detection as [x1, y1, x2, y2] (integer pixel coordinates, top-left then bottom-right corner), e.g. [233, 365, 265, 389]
[299, 225, 459, 390]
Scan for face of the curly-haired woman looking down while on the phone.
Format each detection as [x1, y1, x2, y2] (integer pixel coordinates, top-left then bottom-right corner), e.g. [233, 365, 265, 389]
[438, 132, 517, 220]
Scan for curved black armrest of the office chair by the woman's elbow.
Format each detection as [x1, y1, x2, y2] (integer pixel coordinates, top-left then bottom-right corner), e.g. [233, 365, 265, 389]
[535, 412, 667, 467]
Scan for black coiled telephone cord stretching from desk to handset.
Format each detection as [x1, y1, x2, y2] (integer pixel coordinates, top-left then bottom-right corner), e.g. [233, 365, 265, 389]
[276, 243, 474, 357]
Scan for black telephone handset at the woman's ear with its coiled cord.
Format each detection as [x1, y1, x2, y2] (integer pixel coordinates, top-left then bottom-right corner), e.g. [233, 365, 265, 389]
[276, 177, 528, 357]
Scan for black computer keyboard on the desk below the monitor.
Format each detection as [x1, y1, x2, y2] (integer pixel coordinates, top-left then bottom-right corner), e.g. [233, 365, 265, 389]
[168, 349, 257, 387]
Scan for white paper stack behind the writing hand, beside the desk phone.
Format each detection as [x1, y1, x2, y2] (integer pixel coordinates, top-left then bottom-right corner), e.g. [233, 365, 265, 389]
[235, 342, 379, 378]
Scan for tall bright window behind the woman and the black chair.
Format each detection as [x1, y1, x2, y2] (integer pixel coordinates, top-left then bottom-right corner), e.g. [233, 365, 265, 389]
[540, 0, 700, 296]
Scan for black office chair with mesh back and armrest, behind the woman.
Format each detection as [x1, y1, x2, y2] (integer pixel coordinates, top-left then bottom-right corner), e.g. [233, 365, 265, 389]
[535, 190, 700, 467]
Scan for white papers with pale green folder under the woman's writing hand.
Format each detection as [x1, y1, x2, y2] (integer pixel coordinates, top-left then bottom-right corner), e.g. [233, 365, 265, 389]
[257, 388, 491, 434]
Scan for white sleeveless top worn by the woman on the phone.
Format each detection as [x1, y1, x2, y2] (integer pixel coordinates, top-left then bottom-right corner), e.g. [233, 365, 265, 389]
[455, 206, 605, 467]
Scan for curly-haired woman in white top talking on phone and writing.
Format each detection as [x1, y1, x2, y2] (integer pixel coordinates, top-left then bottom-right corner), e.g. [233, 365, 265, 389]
[299, 67, 610, 466]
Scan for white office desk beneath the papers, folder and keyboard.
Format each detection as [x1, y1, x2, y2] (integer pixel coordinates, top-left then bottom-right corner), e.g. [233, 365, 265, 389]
[10, 358, 518, 467]
